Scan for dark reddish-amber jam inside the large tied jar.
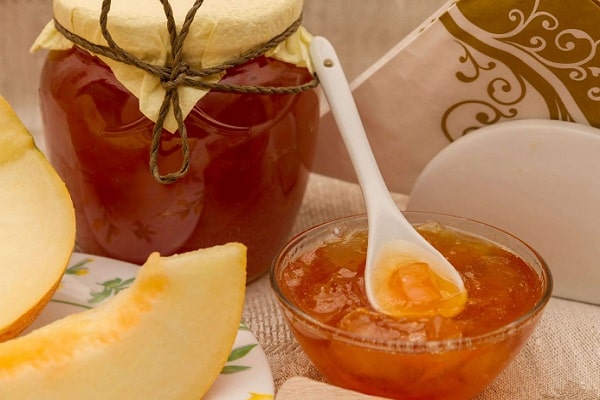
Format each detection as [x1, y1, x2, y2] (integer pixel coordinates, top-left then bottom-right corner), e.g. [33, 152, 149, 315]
[40, 47, 319, 279]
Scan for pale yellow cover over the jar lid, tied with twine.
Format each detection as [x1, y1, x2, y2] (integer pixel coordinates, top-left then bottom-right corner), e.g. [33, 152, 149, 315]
[31, 0, 312, 132]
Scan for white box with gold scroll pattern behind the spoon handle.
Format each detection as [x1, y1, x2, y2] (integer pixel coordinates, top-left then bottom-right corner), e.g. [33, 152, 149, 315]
[316, 0, 600, 193]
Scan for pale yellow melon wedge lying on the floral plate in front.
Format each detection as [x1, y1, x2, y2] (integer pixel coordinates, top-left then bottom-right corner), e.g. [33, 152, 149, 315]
[0, 243, 246, 400]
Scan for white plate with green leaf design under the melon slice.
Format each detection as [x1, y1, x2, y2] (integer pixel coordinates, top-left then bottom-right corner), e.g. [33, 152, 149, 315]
[28, 253, 274, 400]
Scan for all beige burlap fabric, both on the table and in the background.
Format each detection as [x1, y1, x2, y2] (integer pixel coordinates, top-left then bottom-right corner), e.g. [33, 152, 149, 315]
[0, 0, 600, 400]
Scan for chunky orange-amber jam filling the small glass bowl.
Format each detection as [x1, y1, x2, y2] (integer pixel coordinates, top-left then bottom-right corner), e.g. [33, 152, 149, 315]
[272, 217, 550, 399]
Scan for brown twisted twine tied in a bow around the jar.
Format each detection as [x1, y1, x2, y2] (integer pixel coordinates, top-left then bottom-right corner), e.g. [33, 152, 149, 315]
[54, 0, 319, 184]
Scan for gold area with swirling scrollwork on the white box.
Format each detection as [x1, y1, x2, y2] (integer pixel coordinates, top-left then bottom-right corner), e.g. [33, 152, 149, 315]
[440, 0, 600, 141]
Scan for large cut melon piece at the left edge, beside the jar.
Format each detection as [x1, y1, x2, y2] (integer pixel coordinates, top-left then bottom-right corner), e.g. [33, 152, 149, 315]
[0, 97, 75, 341]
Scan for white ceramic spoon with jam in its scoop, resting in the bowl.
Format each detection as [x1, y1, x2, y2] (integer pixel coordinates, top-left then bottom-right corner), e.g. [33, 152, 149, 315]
[310, 37, 466, 317]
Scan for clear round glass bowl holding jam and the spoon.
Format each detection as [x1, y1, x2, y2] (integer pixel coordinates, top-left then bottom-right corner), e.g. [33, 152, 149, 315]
[270, 212, 552, 400]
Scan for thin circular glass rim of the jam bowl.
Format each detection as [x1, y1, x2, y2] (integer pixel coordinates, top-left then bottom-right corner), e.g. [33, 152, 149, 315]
[269, 211, 553, 354]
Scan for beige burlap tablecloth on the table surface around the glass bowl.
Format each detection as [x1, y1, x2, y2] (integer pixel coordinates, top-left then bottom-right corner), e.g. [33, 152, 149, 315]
[244, 174, 600, 400]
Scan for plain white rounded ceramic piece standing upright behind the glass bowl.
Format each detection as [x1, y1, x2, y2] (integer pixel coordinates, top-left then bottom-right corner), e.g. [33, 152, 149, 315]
[407, 120, 600, 304]
